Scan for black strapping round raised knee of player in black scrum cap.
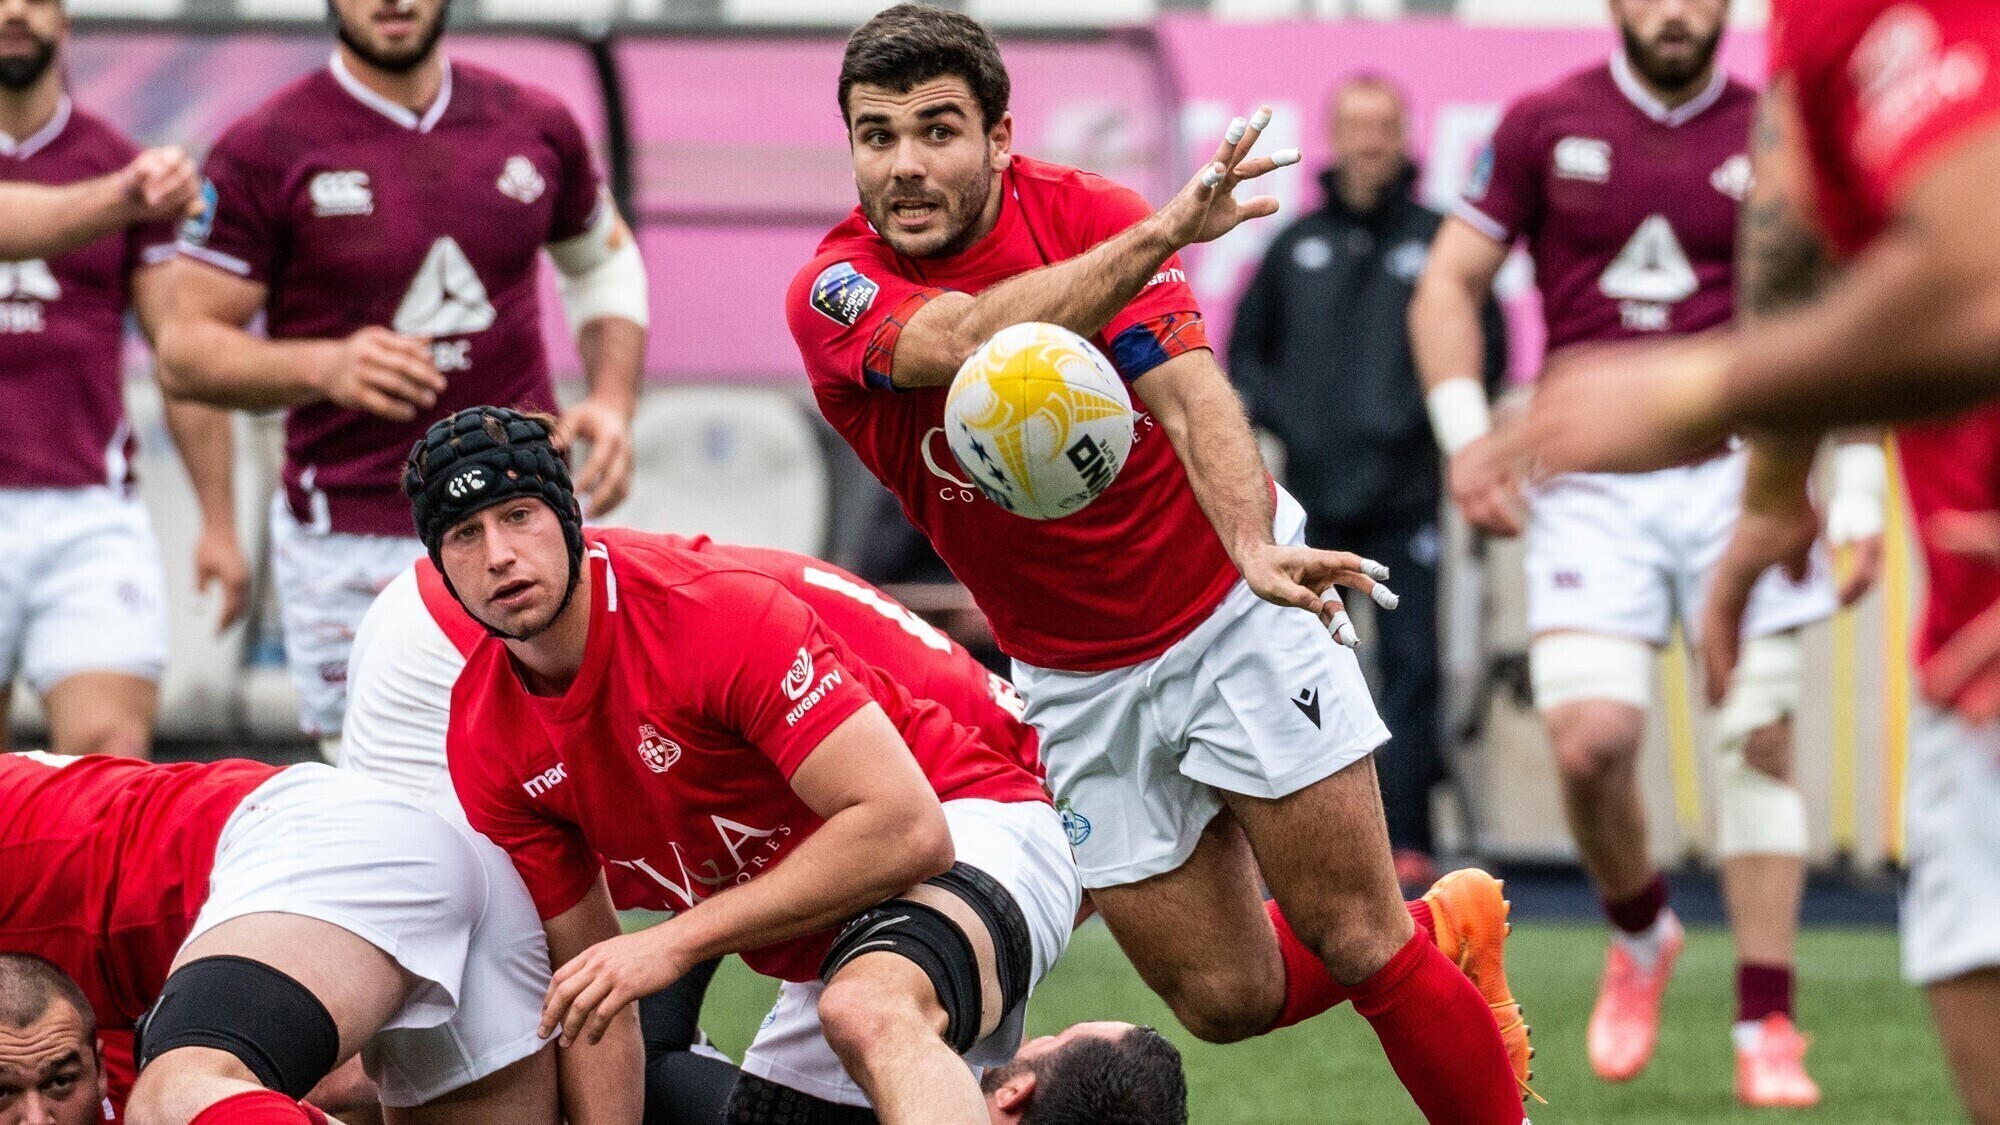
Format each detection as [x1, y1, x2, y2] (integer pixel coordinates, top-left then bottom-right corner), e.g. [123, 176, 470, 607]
[820, 863, 1034, 1055]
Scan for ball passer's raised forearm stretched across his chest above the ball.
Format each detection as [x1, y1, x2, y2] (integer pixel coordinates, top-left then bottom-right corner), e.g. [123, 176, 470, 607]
[892, 218, 1178, 386]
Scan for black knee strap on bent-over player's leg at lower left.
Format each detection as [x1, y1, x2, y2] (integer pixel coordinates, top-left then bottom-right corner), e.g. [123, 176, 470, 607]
[132, 957, 340, 1097]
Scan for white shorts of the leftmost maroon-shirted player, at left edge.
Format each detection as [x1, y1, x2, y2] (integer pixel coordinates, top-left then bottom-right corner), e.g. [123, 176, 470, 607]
[0, 484, 168, 695]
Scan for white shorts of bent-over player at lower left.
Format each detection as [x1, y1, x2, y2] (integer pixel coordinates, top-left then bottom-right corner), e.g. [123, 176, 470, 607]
[186, 763, 550, 1107]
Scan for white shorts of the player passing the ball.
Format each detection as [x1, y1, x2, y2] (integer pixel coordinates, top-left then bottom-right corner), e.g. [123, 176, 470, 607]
[1014, 490, 1394, 887]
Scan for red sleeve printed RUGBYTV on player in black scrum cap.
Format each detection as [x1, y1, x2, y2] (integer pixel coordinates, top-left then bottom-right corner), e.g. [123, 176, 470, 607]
[696, 571, 874, 777]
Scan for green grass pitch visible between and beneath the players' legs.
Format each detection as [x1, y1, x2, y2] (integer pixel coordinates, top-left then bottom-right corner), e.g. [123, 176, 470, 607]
[704, 923, 1964, 1125]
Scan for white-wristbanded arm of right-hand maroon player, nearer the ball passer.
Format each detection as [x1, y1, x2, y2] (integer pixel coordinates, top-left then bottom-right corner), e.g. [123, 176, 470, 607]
[1410, 218, 1522, 536]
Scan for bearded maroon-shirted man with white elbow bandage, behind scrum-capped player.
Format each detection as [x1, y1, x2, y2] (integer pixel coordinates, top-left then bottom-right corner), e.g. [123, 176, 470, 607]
[160, 0, 646, 757]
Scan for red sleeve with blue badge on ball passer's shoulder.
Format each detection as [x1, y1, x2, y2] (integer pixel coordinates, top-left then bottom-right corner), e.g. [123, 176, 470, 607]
[784, 240, 944, 390]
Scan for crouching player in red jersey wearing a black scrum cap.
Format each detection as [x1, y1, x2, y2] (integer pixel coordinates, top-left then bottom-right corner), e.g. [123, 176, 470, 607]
[404, 406, 1082, 1123]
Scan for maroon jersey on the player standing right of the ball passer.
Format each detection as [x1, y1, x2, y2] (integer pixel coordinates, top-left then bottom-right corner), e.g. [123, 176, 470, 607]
[1454, 54, 1756, 352]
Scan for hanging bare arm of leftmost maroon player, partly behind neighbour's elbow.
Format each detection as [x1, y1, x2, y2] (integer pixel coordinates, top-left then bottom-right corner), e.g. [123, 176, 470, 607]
[132, 262, 250, 631]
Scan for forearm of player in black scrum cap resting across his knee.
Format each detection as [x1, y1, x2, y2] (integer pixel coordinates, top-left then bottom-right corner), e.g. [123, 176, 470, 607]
[660, 799, 952, 961]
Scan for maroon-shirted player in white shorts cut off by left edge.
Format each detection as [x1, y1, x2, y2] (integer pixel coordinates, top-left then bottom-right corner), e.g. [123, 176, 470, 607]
[0, 0, 250, 757]
